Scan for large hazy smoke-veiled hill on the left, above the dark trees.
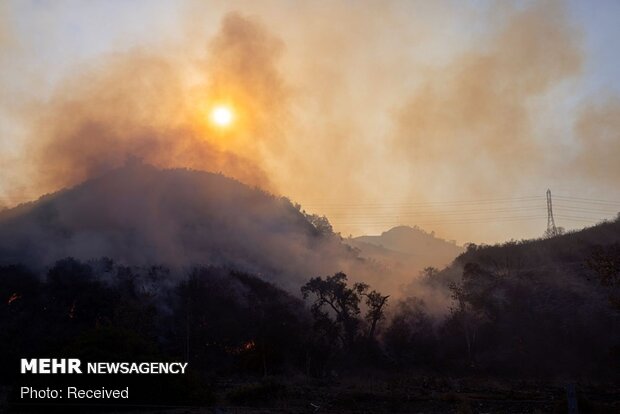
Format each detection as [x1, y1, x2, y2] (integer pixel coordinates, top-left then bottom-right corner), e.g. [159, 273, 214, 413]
[0, 162, 368, 290]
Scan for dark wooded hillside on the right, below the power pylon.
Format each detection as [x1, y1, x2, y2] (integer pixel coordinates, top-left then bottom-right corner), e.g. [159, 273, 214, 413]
[410, 220, 620, 377]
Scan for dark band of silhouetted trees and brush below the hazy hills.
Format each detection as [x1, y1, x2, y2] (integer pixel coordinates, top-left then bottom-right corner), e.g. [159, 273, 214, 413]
[0, 217, 620, 404]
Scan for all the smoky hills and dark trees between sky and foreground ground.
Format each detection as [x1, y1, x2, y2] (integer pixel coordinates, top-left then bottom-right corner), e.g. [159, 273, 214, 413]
[0, 160, 620, 406]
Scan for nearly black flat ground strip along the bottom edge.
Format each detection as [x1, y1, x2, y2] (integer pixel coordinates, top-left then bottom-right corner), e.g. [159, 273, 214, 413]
[5, 376, 620, 414]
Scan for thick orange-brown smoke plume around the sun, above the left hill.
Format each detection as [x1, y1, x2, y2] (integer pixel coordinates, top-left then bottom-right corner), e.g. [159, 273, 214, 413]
[2, 10, 286, 201]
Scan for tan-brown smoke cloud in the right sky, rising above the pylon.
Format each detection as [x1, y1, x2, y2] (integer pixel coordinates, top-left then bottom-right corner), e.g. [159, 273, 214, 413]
[393, 3, 582, 194]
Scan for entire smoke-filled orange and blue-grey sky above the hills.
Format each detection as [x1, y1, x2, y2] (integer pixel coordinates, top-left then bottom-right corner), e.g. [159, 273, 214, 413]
[0, 0, 620, 243]
